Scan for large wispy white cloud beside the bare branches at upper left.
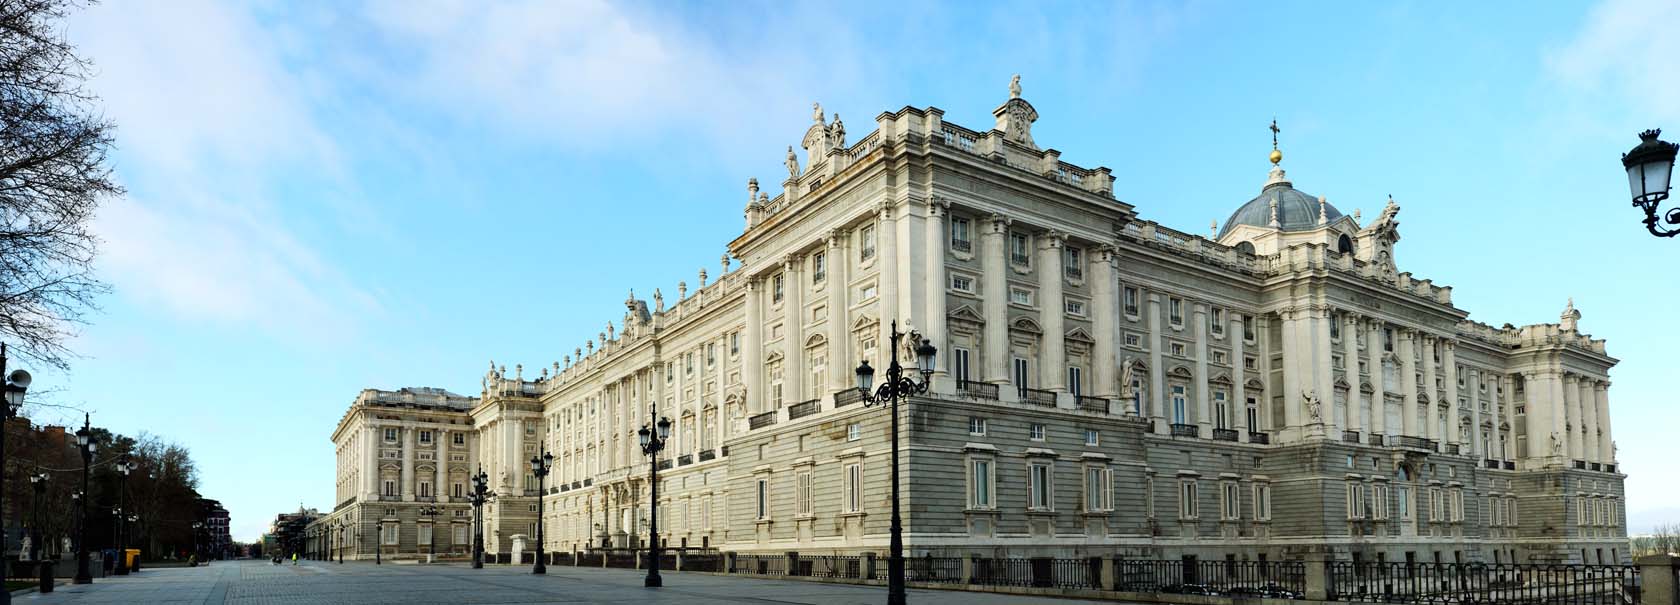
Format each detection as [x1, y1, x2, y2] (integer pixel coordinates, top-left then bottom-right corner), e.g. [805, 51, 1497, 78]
[69, 2, 376, 336]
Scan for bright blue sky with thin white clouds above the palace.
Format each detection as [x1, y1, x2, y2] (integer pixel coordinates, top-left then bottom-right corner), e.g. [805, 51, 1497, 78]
[26, 0, 1680, 539]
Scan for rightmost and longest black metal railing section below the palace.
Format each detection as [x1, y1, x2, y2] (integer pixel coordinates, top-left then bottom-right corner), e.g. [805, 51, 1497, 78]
[1326, 561, 1640, 605]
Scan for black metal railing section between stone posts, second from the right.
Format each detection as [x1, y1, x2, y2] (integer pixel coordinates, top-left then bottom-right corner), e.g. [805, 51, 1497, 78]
[1114, 560, 1307, 598]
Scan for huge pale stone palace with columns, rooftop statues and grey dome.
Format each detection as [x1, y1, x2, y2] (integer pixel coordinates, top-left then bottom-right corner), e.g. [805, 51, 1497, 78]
[323, 82, 1628, 563]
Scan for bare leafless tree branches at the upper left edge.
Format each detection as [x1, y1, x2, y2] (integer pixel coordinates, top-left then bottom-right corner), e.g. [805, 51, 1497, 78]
[0, 0, 123, 368]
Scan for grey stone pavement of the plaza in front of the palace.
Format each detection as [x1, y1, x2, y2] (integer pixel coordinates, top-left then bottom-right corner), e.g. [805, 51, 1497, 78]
[13, 561, 1114, 605]
